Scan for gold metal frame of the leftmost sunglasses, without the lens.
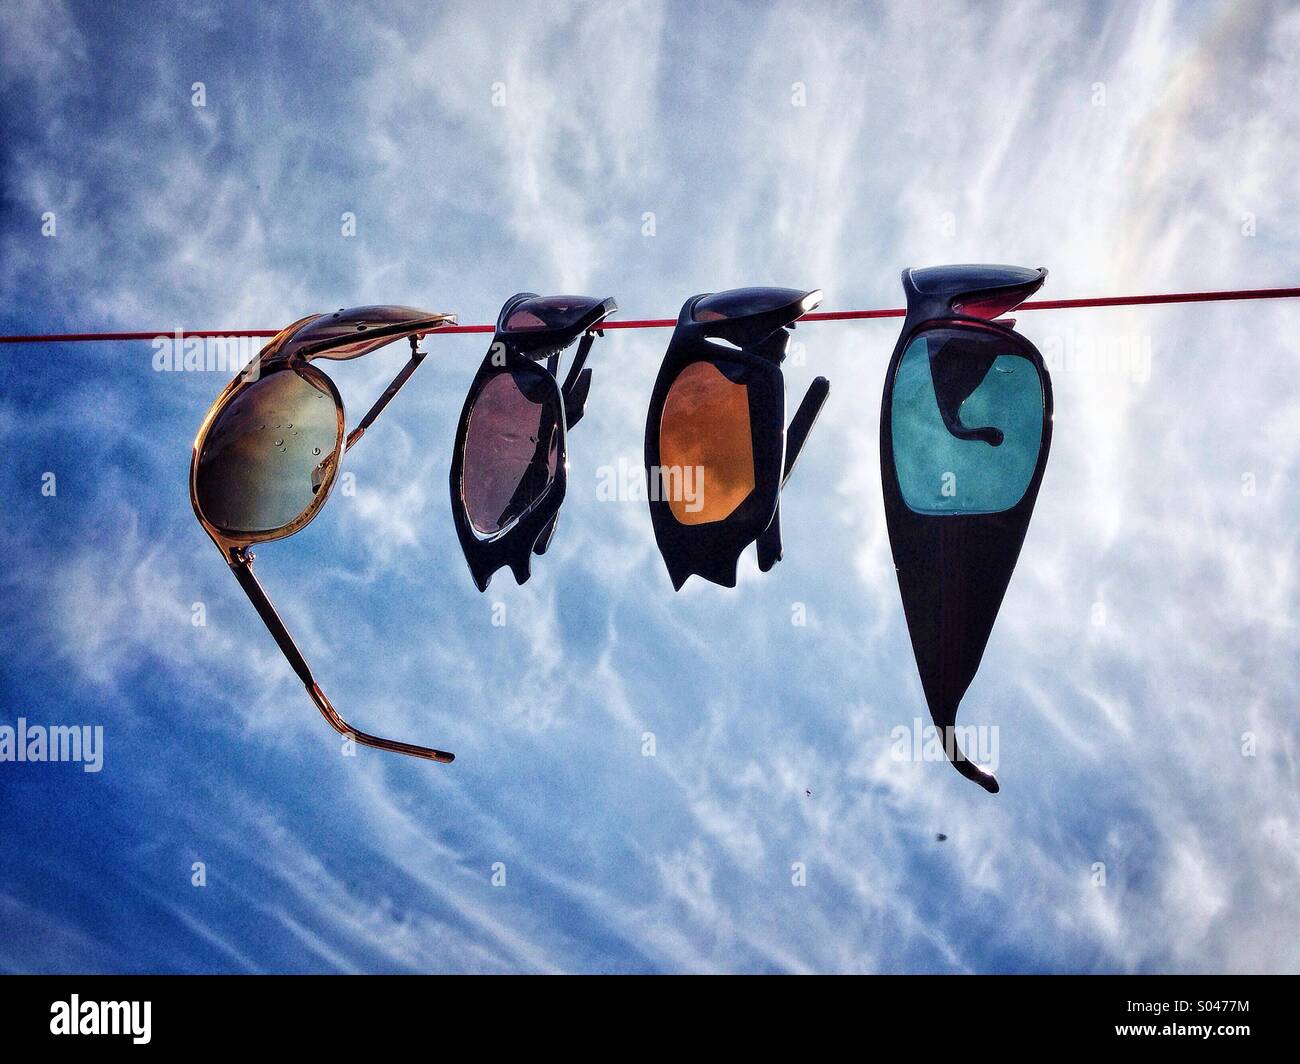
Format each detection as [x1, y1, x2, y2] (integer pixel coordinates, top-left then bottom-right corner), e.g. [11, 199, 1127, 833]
[190, 306, 456, 764]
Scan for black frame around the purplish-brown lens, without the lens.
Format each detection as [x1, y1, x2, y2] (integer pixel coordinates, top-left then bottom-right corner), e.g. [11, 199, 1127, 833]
[449, 291, 619, 592]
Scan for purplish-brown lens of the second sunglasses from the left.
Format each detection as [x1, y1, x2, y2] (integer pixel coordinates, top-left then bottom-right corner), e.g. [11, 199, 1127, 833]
[462, 367, 560, 536]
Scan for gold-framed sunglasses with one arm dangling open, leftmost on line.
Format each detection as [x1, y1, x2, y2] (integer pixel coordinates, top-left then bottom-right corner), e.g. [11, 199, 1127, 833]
[190, 307, 456, 764]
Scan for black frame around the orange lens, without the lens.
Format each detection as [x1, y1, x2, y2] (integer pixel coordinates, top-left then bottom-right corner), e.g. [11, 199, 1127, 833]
[645, 290, 831, 591]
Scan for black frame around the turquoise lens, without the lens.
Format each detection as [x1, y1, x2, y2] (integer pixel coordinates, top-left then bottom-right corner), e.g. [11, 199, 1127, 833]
[880, 267, 1053, 793]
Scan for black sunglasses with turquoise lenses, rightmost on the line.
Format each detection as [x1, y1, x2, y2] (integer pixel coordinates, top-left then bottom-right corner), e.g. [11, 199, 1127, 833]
[880, 265, 1052, 793]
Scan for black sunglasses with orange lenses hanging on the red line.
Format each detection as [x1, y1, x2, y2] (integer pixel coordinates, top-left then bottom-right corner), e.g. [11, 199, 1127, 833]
[645, 287, 831, 591]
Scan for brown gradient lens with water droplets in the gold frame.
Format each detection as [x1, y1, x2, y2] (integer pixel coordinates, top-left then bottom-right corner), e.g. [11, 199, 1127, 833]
[195, 369, 342, 535]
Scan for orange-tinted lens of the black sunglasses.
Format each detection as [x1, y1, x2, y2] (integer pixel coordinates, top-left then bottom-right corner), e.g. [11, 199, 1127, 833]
[659, 362, 754, 524]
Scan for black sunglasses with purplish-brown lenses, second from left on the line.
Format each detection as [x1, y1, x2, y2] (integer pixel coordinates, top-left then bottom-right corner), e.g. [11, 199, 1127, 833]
[451, 293, 618, 591]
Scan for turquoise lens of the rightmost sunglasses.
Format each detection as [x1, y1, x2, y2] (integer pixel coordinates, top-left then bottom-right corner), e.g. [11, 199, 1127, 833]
[891, 326, 1044, 514]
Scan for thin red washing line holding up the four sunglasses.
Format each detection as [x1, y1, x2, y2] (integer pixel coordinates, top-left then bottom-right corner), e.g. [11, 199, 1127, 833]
[0, 287, 1300, 343]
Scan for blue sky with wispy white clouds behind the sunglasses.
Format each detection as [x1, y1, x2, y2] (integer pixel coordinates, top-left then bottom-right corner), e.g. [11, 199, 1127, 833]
[0, 0, 1300, 972]
